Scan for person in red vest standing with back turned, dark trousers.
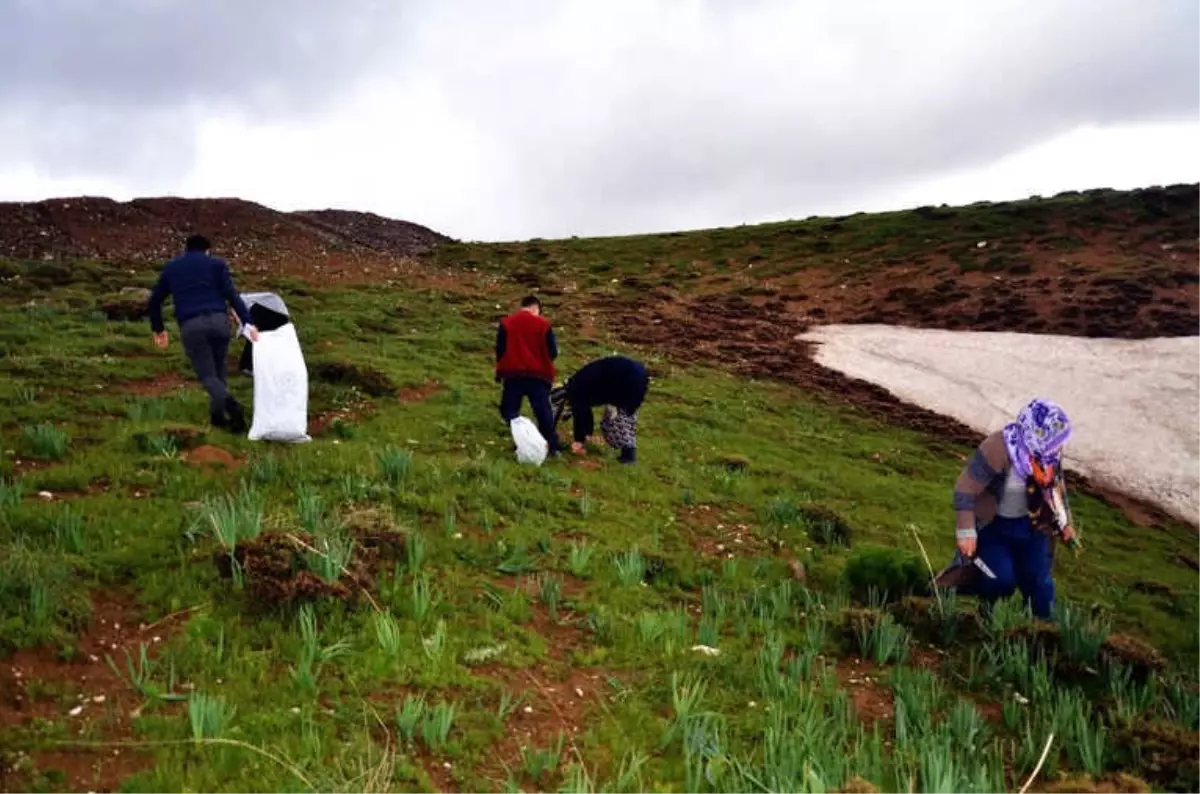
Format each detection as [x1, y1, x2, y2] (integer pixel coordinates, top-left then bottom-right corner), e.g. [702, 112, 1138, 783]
[496, 295, 562, 455]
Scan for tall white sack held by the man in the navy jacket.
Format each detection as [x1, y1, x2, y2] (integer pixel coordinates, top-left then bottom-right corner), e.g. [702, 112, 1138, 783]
[250, 323, 312, 444]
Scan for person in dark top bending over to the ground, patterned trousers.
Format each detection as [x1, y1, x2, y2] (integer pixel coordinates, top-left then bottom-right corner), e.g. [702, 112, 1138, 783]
[550, 356, 649, 463]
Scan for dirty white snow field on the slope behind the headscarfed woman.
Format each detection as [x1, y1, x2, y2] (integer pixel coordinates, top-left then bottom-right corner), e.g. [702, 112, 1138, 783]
[797, 325, 1200, 527]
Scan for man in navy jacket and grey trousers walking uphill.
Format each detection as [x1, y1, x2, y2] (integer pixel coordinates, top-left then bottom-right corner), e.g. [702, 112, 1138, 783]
[149, 235, 258, 433]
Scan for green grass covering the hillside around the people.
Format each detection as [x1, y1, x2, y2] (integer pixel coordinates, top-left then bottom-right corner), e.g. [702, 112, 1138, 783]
[0, 239, 1200, 793]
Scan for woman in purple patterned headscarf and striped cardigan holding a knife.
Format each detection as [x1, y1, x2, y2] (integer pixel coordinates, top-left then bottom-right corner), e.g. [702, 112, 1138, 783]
[938, 399, 1075, 619]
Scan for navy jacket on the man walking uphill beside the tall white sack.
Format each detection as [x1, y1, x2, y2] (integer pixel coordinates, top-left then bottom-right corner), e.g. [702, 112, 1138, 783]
[149, 251, 253, 333]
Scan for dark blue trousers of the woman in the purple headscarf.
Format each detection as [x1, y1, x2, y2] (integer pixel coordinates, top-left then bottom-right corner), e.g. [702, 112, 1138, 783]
[967, 516, 1055, 620]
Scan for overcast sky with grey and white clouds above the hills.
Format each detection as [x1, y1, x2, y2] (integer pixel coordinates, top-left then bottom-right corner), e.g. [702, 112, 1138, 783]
[0, 0, 1200, 240]
